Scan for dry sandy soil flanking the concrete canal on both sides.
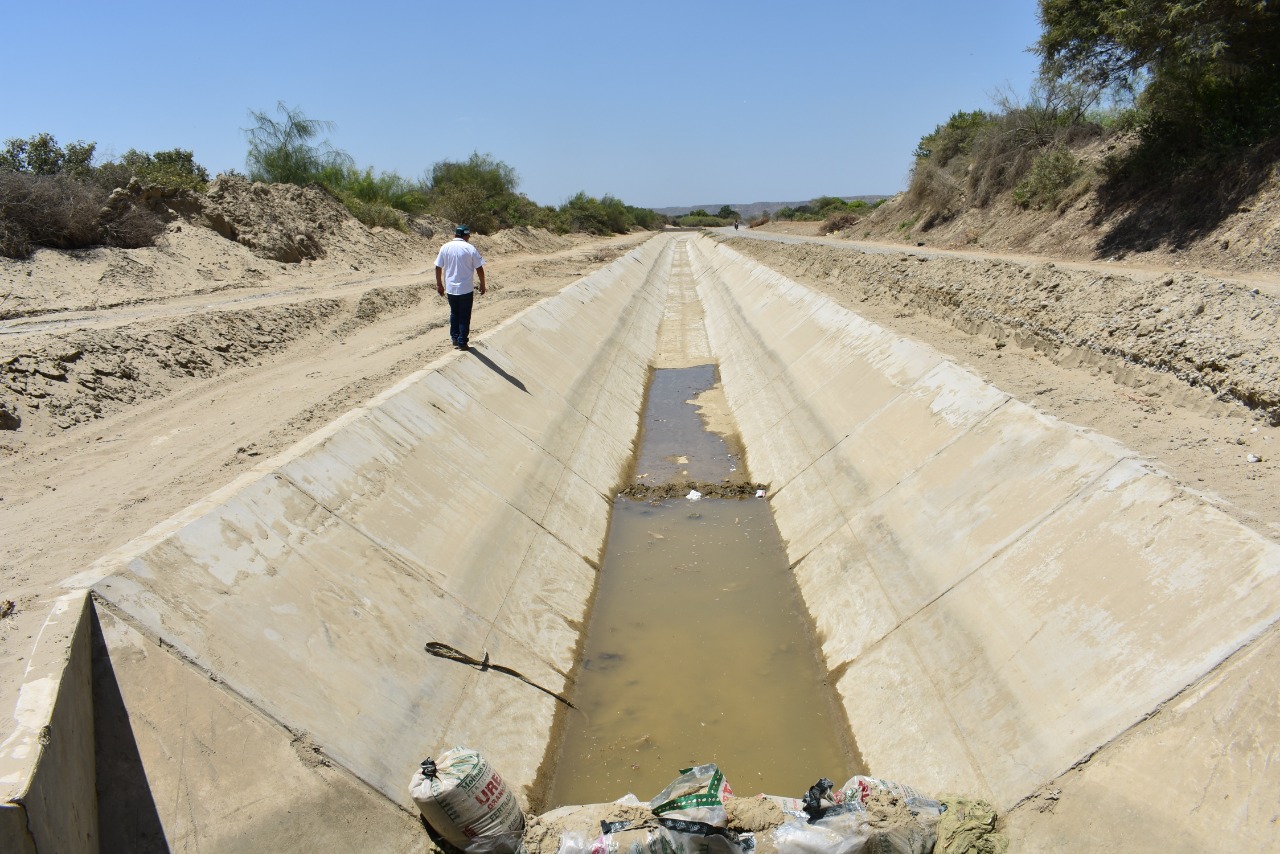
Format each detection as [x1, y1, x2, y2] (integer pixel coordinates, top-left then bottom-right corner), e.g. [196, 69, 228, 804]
[0, 175, 1280, 804]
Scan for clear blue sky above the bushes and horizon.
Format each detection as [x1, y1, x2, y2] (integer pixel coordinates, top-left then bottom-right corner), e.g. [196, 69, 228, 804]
[0, 0, 1039, 207]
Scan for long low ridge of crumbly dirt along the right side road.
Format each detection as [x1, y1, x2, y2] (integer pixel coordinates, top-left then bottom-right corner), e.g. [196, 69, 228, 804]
[732, 239, 1280, 424]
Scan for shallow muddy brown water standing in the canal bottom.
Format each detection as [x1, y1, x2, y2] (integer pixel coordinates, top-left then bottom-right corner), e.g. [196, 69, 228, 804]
[547, 365, 863, 808]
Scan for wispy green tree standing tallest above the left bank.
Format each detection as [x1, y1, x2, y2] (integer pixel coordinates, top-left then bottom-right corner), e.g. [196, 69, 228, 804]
[244, 101, 352, 184]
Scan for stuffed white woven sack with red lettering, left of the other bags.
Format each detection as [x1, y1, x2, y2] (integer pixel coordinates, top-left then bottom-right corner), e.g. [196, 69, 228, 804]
[408, 748, 525, 854]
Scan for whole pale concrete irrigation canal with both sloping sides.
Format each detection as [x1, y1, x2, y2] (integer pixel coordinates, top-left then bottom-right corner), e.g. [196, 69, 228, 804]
[0, 234, 1280, 851]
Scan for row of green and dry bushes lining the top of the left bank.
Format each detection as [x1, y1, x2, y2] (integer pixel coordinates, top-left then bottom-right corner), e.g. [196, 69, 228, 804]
[0, 101, 675, 257]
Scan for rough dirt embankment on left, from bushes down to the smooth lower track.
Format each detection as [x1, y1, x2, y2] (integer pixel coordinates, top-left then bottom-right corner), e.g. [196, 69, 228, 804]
[0, 178, 586, 452]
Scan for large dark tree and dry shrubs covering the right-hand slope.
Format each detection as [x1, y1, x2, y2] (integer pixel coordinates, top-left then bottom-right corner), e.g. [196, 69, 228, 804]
[884, 0, 1280, 256]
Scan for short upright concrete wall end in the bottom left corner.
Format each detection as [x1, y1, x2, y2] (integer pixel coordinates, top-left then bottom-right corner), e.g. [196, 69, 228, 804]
[0, 590, 99, 854]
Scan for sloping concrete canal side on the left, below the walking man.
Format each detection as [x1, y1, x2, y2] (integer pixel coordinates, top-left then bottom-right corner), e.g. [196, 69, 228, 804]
[0, 230, 671, 850]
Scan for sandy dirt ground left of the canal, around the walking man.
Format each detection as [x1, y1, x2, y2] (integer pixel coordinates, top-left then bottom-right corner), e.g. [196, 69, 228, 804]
[0, 215, 650, 732]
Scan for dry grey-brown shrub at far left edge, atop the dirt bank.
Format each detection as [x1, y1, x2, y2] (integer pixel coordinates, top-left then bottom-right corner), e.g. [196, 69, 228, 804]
[0, 172, 164, 257]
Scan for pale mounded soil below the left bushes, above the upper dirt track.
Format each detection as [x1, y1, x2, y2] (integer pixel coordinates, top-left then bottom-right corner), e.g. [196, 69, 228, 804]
[0, 175, 582, 321]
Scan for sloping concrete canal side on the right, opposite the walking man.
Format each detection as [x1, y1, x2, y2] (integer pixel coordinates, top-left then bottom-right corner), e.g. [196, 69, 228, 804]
[691, 239, 1280, 848]
